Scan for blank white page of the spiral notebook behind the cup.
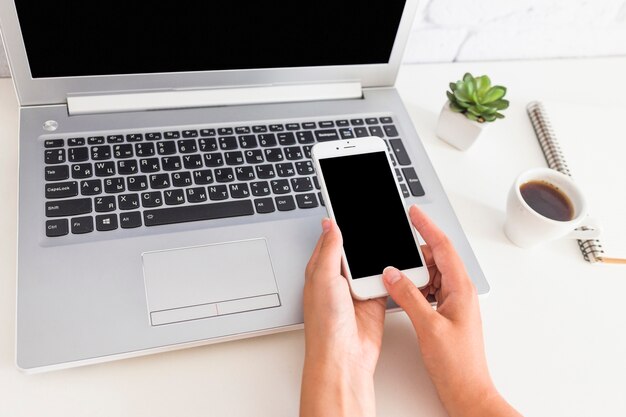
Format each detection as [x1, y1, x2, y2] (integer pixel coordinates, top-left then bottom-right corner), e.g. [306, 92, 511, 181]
[543, 101, 626, 258]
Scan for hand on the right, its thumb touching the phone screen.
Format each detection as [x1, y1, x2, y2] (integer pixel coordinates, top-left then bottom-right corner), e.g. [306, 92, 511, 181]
[383, 206, 519, 417]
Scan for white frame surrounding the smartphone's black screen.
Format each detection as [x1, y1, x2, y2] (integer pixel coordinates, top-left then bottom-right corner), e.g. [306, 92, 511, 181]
[311, 136, 429, 300]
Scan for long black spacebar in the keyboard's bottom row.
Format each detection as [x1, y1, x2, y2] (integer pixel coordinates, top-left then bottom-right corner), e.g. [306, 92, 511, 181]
[143, 200, 254, 226]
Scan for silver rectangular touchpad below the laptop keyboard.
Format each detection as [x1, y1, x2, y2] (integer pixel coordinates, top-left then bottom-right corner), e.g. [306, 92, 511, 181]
[142, 239, 280, 326]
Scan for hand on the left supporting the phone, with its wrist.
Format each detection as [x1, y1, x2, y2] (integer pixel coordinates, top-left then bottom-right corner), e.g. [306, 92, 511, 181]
[300, 219, 386, 416]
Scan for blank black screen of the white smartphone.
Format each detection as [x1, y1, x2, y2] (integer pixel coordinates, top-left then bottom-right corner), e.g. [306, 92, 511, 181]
[319, 151, 422, 279]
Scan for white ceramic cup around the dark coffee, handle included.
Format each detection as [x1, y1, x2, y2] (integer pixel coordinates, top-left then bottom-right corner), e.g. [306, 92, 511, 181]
[504, 168, 600, 248]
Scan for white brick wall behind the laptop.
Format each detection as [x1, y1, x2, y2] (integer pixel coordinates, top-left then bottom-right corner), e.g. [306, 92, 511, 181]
[0, 0, 626, 76]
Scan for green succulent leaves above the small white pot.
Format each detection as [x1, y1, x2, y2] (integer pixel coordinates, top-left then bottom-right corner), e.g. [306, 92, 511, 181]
[446, 72, 509, 123]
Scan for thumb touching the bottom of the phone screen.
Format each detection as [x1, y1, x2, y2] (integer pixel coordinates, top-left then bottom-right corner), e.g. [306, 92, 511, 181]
[383, 266, 436, 331]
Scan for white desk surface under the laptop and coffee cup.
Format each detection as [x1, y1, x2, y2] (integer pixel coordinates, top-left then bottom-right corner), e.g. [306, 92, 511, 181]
[0, 57, 626, 417]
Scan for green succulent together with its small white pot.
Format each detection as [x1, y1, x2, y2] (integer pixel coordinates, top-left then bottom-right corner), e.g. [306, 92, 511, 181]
[435, 72, 509, 150]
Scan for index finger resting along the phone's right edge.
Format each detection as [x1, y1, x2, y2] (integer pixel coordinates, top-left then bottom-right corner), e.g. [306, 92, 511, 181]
[409, 205, 467, 280]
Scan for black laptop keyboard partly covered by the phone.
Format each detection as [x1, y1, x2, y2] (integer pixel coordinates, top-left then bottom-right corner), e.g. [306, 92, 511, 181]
[43, 117, 424, 237]
